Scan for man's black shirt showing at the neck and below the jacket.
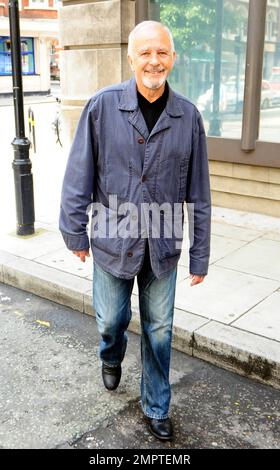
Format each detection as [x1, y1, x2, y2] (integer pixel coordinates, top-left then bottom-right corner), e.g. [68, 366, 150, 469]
[137, 84, 169, 271]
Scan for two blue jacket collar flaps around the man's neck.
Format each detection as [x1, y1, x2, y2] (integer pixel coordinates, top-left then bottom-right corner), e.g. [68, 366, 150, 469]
[119, 77, 184, 117]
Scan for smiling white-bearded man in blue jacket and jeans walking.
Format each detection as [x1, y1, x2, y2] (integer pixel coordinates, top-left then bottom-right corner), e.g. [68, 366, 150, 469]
[60, 21, 211, 440]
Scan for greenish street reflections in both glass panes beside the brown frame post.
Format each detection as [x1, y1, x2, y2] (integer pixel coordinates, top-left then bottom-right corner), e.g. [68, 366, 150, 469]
[150, 0, 280, 142]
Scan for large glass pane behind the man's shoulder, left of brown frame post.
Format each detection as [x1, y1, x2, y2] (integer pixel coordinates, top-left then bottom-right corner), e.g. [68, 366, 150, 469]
[150, 0, 249, 138]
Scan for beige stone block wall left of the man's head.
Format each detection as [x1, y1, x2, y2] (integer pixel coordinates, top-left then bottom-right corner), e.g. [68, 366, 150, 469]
[59, 0, 135, 142]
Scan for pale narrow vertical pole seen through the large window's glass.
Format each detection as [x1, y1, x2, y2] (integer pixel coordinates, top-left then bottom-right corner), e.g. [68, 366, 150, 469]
[208, 0, 224, 136]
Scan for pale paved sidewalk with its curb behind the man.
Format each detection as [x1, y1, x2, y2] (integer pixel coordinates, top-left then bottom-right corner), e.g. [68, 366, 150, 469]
[0, 207, 280, 389]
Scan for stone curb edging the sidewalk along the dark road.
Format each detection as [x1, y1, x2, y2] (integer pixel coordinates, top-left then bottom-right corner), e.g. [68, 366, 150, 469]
[0, 251, 280, 389]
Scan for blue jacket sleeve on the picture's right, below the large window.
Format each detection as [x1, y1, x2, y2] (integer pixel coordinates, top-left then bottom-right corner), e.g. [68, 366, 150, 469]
[186, 110, 211, 275]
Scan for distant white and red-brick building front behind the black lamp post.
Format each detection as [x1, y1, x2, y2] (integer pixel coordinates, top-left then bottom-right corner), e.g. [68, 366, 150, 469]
[0, 0, 59, 95]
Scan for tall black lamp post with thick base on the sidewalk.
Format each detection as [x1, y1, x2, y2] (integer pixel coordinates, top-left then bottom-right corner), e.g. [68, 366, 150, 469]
[9, 0, 35, 235]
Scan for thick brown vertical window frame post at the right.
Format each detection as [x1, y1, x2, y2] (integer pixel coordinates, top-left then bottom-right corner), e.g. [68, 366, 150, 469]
[241, 0, 266, 151]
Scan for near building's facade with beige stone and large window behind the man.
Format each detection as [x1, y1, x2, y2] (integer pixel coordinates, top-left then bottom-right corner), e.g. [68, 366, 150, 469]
[59, 0, 280, 216]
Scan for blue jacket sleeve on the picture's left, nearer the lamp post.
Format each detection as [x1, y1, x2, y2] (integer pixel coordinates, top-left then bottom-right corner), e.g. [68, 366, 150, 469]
[59, 101, 94, 251]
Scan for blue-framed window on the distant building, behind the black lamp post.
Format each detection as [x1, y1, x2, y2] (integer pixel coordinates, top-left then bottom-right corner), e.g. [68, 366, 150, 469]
[0, 36, 35, 75]
